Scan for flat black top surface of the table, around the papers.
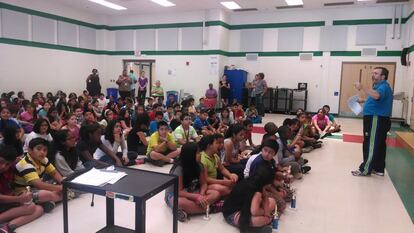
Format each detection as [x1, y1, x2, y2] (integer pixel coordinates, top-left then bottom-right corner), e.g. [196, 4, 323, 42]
[64, 167, 178, 199]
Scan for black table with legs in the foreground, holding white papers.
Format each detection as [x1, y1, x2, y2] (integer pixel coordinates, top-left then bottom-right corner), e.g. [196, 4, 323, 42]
[63, 167, 178, 233]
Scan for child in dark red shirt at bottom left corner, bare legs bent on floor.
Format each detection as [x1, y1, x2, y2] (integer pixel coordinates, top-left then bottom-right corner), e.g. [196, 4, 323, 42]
[0, 147, 43, 233]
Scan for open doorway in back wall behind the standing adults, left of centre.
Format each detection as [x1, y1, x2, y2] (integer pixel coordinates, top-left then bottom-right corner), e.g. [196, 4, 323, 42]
[123, 59, 156, 97]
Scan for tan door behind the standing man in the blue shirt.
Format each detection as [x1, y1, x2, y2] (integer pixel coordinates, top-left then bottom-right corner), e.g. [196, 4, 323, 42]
[339, 62, 396, 117]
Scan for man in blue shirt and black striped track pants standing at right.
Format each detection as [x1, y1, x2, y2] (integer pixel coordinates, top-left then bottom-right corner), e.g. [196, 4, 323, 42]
[352, 67, 393, 176]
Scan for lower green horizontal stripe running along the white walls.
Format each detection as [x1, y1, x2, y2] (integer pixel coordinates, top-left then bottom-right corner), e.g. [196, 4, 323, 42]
[0, 38, 408, 57]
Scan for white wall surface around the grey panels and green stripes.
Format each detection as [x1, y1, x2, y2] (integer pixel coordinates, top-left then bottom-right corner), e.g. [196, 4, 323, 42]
[0, 0, 414, 123]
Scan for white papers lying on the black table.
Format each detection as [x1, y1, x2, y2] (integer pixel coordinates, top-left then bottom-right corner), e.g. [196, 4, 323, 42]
[72, 168, 127, 186]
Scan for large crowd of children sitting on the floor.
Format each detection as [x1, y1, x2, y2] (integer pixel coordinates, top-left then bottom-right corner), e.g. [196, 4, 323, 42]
[0, 88, 339, 232]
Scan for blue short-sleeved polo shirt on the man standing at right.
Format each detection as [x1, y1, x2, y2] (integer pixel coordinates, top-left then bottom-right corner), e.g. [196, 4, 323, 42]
[364, 80, 393, 117]
